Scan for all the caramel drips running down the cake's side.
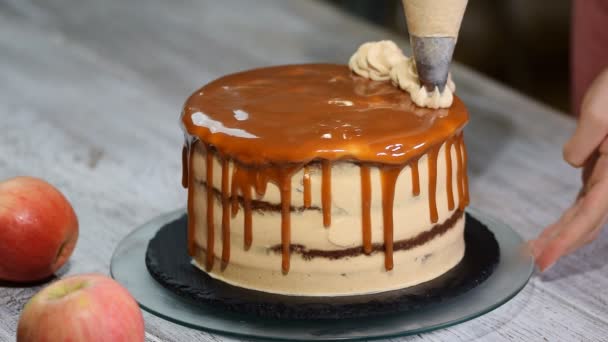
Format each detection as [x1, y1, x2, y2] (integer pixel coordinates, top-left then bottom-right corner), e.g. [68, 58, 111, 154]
[182, 133, 468, 274]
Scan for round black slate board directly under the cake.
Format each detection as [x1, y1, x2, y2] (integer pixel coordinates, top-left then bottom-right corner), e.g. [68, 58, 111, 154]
[146, 214, 500, 319]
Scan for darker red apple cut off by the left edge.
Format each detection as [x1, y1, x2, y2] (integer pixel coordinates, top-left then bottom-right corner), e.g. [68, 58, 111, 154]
[0, 177, 78, 282]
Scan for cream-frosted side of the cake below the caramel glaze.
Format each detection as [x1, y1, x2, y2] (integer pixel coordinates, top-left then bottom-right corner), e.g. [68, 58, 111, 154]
[183, 136, 467, 296]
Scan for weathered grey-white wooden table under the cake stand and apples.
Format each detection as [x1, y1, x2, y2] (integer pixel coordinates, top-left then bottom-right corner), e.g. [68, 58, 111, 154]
[0, 0, 608, 341]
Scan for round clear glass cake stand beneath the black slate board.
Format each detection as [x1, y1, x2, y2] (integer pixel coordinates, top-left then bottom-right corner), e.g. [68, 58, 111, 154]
[110, 209, 534, 341]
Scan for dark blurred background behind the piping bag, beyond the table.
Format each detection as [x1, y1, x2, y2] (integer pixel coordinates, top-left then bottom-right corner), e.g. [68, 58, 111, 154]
[325, 0, 571, 113]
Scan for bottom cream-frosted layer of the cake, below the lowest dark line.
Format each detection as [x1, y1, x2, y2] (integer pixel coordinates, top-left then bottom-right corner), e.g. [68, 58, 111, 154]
[193, 216, 465, 296]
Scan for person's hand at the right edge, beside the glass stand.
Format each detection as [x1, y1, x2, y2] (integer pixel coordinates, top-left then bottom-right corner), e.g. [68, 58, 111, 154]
[529, 69, 608, 271]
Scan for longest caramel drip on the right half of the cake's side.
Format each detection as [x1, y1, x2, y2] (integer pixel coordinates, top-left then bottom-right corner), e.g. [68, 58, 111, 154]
[380, 166, 402, 271]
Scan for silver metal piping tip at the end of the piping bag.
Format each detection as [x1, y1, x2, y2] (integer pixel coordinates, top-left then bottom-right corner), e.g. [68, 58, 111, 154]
[410, 35, 456, 92]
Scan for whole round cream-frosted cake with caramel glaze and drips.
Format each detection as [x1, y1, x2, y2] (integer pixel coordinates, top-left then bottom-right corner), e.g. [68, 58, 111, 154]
[181, 48, 468, 296]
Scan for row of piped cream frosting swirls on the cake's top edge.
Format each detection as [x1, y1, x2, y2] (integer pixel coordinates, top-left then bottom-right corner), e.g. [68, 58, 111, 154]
[348, 40, 456, 109]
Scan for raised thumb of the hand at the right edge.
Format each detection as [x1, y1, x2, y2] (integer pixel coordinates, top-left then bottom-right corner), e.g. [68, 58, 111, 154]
[563, 69, 608, 167]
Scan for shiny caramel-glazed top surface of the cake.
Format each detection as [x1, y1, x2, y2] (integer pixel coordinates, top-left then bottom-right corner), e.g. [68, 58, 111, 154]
[181, 64, 468, 164]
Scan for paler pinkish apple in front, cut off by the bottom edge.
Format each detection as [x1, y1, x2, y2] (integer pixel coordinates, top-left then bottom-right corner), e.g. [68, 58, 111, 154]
[17, 274, 145, 342]
